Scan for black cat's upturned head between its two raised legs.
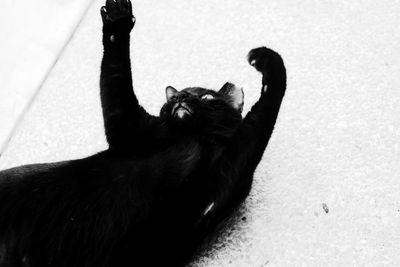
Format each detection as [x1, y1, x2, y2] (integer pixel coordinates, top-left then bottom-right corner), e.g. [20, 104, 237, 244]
[160, 83, 244, 136]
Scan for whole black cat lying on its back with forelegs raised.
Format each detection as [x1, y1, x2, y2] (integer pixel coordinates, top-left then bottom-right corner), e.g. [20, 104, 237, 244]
[0, 0, 286, 267]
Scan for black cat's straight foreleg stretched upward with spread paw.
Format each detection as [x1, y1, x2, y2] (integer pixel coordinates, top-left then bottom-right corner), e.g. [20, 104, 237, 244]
[100, 0, 155, 148]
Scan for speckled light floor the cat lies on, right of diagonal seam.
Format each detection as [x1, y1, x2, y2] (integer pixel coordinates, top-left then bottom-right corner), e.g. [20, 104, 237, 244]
[0, 0, 400, 267]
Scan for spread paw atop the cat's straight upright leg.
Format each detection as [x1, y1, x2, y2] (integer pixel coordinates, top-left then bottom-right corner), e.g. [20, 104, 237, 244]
[100, 0, 136, 32]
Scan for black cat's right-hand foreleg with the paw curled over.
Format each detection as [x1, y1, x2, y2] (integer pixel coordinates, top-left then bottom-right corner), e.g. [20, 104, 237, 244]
[198, 47, 286, 232]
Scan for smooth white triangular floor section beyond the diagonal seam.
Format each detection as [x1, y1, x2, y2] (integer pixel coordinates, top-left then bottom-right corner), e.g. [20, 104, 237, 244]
[0, 0, 93, 154]
